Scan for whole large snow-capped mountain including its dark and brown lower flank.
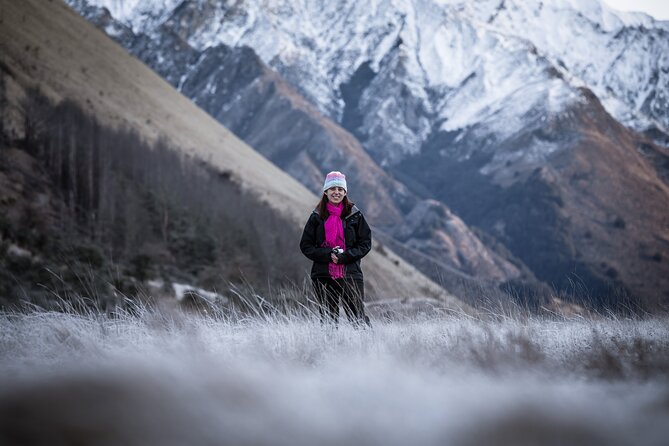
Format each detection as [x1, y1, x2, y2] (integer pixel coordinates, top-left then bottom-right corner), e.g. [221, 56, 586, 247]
[69, 0, 669, 310]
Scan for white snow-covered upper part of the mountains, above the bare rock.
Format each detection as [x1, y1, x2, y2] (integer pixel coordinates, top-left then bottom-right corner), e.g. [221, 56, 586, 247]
[72, 0, 669, 152]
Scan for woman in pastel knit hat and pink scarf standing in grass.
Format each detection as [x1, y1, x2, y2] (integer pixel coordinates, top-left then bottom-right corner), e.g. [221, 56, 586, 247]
[300, 172, 372, 326]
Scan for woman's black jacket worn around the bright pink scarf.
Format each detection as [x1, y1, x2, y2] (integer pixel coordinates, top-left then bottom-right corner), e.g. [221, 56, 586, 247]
[300, 206, 372, 280]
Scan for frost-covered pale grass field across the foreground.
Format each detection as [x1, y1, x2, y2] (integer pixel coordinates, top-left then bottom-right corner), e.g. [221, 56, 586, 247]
[0, 309, 669, 445]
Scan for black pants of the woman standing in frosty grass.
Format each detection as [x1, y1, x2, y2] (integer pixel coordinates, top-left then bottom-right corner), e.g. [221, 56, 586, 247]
[312, 279, 371, 327]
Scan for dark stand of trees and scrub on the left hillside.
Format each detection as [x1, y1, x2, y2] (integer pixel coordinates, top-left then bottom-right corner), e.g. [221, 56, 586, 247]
[0, 82, 304, 307]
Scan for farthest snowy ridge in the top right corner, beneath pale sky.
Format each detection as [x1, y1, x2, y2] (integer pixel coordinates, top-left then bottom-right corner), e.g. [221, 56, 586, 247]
[467, 0, 669, 139]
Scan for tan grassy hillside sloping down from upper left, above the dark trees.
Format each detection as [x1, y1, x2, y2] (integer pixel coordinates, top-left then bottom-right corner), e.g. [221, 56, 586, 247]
[0, 0, 464, 304]
